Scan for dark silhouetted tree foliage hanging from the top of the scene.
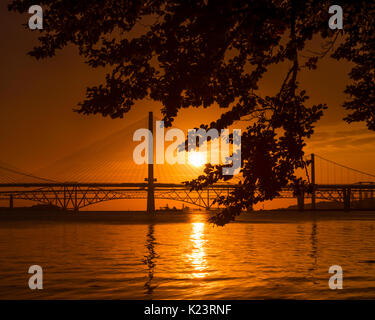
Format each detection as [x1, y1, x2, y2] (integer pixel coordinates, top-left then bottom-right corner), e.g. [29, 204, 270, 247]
[9, 0, 375, 225]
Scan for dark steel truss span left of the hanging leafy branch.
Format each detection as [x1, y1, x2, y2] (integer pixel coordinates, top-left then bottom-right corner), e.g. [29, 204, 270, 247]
[0, 183, 234, 211]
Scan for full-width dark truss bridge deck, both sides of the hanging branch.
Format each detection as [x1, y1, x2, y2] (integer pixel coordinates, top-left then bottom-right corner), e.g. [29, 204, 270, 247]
[0, 183, 375, 211]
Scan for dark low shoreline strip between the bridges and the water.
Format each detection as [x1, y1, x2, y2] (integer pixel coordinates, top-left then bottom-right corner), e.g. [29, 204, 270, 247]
[0, 208, 375, 225]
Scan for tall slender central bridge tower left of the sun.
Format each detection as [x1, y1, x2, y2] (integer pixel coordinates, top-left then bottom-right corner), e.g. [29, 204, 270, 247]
[145, 112, 156, 214]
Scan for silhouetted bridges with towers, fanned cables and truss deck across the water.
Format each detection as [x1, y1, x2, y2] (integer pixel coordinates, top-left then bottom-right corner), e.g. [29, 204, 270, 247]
[0, 113, 375, 213]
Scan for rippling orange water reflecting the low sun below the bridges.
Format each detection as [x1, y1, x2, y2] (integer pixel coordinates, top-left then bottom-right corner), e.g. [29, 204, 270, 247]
[0, 214, 375, 299]
